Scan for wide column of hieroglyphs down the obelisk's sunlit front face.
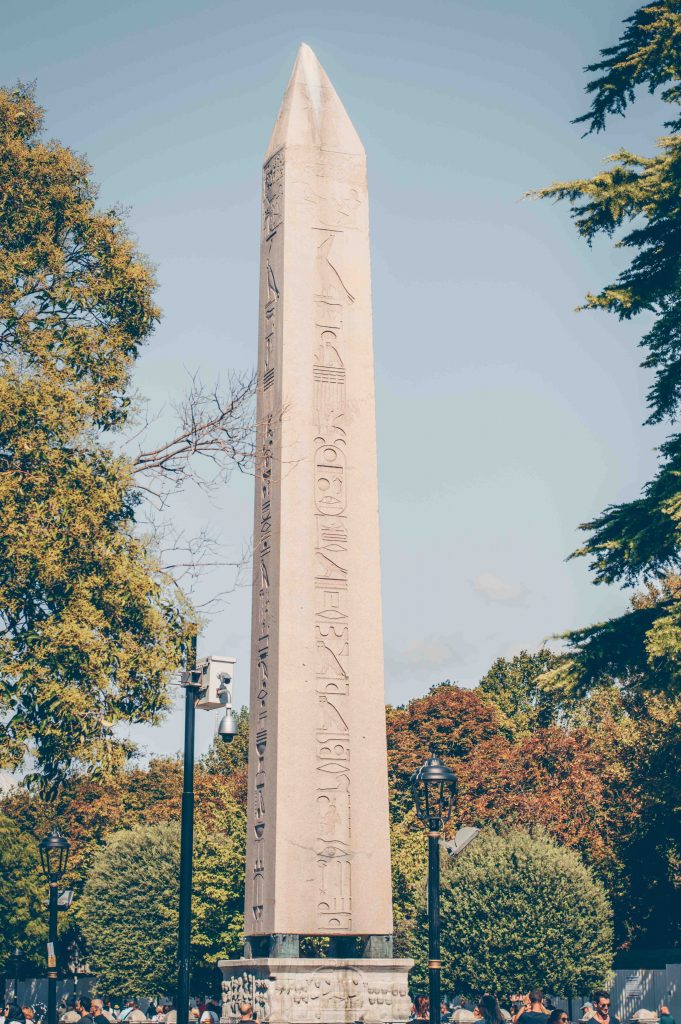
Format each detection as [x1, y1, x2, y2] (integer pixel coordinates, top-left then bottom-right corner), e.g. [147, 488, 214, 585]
[311, 165, 358, 933]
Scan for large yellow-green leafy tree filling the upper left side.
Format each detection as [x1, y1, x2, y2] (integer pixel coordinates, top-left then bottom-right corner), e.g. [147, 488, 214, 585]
[0, 87, 196, 783]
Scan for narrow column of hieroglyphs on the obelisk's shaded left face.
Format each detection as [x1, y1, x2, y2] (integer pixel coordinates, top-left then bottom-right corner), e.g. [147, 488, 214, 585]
[250, 152, 284, 931]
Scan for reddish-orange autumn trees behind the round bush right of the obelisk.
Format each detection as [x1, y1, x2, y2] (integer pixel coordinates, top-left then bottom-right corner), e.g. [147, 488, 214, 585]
[388, 667, 681, 947]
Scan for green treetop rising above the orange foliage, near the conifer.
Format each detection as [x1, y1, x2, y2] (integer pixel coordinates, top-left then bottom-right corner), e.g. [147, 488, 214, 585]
[475, 647, 564, 738]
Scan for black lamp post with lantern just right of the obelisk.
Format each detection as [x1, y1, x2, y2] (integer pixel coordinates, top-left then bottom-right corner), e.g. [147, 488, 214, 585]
[411, 755, 457, 1024]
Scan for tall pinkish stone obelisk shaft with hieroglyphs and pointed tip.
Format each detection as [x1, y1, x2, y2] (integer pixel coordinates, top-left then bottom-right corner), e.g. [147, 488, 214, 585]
[246, 45, 392, 936]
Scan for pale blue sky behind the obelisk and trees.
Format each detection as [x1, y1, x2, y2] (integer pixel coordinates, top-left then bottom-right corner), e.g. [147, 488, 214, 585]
[0, 0, 662, 753]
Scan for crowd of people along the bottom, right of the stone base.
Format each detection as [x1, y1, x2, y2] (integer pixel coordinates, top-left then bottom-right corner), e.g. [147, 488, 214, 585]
[410, 988, 676, 1024]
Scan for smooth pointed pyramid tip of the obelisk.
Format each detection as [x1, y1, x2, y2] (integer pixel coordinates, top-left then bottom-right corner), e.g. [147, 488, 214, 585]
[265, 43, 365, 163]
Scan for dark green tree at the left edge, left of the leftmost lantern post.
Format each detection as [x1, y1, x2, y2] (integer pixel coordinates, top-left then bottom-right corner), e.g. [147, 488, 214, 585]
[0, 814, 47, 964]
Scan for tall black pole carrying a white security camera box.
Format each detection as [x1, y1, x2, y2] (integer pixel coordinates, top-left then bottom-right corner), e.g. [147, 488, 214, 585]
[176, 651, 239, 1024]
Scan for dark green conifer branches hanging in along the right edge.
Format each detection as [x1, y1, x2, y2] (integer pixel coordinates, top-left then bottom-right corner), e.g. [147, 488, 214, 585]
[535, 0, 681, 692]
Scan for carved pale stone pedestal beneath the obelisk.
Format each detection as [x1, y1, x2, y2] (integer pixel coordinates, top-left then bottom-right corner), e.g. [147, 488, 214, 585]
[218, 957, 414, 1024]
